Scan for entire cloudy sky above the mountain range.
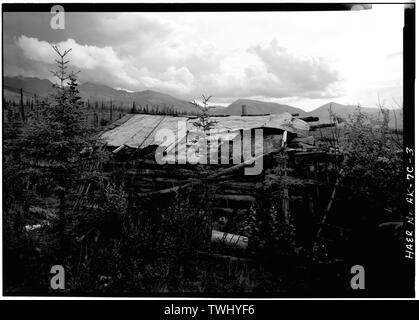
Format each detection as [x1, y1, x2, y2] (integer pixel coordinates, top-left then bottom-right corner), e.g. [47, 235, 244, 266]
[3, 4, 404, 111]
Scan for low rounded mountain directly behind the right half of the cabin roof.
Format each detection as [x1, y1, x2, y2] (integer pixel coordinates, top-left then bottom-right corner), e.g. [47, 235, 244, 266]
[212, 99, 306, 116]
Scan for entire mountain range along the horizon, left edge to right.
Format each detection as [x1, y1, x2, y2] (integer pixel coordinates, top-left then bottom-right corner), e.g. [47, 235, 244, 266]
[3, 76, 403, 129]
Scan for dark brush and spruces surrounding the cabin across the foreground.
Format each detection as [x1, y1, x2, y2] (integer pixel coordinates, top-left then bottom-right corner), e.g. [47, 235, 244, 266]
[3, 49, 404, 297]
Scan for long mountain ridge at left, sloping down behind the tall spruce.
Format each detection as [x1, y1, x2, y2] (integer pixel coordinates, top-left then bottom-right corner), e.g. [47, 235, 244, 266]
[3, 77, 197, 113]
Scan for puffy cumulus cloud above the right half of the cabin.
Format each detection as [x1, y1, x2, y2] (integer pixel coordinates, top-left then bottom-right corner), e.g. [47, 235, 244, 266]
[180, 40, 341, 98]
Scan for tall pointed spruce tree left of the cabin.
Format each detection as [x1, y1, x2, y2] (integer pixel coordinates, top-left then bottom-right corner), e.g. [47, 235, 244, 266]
[20, 46, 93, 249]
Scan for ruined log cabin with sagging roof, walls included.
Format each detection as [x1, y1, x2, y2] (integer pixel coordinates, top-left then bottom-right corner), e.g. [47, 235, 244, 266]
[100, 113, 341, 247]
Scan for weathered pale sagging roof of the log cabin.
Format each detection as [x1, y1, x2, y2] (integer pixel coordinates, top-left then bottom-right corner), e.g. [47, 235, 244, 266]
[101, 112, 310, 149]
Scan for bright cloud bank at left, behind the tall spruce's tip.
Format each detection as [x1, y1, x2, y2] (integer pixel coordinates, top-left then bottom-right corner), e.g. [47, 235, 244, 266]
[7, 36, 200, 95]
